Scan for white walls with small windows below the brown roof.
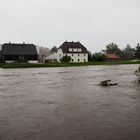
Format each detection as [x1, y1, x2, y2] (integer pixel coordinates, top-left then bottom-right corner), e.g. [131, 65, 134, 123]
[57, 49, 88, 63]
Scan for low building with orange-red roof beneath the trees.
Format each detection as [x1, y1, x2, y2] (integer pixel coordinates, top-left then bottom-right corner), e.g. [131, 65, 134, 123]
[103, 53, 120, 61]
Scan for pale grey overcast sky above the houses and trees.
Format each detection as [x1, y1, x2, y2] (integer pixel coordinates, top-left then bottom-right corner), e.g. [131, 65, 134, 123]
[0, 0, 140, 52]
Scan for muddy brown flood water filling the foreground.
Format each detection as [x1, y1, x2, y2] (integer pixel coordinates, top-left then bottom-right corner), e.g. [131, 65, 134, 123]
[0, 65, 140, 140]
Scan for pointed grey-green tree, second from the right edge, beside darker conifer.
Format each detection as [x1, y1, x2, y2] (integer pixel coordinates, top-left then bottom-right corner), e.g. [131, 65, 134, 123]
[123, 44, 135, 59]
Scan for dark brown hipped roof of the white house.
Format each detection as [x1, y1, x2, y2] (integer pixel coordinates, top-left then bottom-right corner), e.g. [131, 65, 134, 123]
[59, 41, 88, 53]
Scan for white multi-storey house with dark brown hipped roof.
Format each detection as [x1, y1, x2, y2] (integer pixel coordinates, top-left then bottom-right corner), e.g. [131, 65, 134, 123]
[57, 41, 88, 63]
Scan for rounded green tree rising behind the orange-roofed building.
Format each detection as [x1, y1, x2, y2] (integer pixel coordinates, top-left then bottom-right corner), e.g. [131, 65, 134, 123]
[106, 43, 123, 58]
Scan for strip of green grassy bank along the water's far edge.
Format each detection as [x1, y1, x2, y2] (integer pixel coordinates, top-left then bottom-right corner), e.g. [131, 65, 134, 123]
[0, 60, 140, 68]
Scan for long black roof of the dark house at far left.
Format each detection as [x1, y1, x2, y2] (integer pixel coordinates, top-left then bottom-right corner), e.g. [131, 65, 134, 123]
[2, 43, 37, 55]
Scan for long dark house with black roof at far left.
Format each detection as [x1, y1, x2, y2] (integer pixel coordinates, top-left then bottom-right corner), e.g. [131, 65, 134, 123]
[1, 43, 38, 61]
